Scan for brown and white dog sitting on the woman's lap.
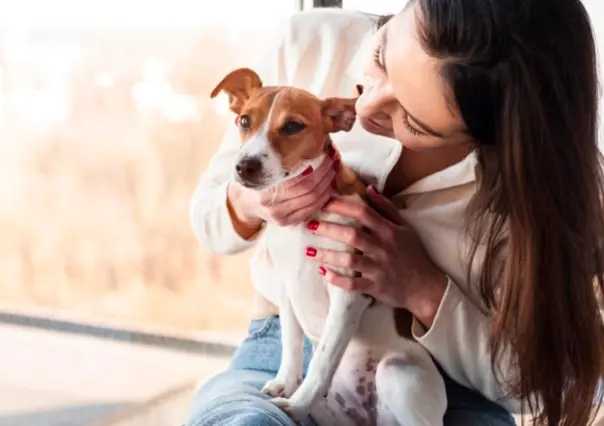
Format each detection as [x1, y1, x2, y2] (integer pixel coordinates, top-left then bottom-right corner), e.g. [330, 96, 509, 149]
[211, 68, 447, 426]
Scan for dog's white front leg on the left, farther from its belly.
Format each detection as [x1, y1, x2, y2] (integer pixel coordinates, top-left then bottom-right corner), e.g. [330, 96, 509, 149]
[262, 291, 304, 398]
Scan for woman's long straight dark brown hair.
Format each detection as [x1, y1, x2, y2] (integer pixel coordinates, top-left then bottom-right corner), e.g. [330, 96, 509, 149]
[384, 0, 604, 426]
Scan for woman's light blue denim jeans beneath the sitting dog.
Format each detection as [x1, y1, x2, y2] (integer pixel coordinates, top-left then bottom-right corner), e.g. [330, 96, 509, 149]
[186, 317, 515, 426]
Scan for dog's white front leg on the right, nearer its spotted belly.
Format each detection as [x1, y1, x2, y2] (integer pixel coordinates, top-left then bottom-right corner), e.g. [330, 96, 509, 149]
[272, 285, 371, 419]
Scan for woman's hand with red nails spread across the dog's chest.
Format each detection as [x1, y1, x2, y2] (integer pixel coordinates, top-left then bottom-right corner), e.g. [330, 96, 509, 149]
[306, 186, 448, 328]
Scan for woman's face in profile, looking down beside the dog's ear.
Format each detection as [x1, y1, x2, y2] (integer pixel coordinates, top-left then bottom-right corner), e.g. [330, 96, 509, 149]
[356, 7, 471, 150]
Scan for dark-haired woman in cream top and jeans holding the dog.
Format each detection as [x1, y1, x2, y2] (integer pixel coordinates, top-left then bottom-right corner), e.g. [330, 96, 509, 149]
[188, 0, 604, 426]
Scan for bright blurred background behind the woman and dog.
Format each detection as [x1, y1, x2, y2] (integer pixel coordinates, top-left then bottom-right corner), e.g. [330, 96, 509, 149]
[0, 0, 604, 426]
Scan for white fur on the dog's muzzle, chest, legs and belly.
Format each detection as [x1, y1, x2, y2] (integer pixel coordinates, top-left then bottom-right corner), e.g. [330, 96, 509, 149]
[233, 95, 447, 426]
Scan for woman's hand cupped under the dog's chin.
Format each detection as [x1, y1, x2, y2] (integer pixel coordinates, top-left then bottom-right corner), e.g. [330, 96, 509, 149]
[228, 154, 336, 237]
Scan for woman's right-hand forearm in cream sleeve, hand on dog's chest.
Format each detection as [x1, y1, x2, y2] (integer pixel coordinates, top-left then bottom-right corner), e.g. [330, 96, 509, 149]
[312, 187, 521, 412]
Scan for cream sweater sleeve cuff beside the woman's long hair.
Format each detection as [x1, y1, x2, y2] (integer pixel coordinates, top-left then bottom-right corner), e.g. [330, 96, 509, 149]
[413, 279, 521, 413]
